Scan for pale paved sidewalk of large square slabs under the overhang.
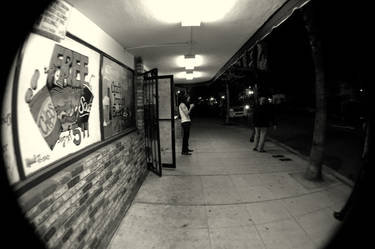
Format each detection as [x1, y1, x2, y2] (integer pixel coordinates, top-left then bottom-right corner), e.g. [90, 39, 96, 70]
[109, 120, 351, 249]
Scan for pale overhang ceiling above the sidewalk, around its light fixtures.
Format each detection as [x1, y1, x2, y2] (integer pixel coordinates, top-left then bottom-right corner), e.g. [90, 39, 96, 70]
[68, 0, 287, 84]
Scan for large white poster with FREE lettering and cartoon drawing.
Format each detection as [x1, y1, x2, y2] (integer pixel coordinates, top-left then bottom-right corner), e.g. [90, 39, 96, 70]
[17, 34, 101, 176]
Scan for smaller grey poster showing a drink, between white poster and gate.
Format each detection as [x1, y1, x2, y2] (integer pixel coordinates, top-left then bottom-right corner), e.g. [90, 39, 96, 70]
[101, 56, 135, 138]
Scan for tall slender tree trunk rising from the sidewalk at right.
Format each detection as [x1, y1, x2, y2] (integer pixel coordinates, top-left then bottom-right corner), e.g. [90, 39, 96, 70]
[303, 3, 327, 181]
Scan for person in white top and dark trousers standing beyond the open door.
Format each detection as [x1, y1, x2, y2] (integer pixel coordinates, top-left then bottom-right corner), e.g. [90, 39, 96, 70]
[178, 94, 194, 155]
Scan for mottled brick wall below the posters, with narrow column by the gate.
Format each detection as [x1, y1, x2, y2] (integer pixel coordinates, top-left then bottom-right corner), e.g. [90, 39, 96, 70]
[15, 57, 148, 249]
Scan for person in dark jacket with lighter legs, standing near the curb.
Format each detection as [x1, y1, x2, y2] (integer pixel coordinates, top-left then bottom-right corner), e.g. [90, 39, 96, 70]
[253, 97, 276, 152]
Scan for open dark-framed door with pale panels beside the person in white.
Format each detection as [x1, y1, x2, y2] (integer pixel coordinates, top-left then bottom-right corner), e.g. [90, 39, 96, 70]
[158, 75, 176, 168]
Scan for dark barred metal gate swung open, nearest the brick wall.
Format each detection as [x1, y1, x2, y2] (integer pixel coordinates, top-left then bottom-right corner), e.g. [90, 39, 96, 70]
[143, 68, 162, 176]
